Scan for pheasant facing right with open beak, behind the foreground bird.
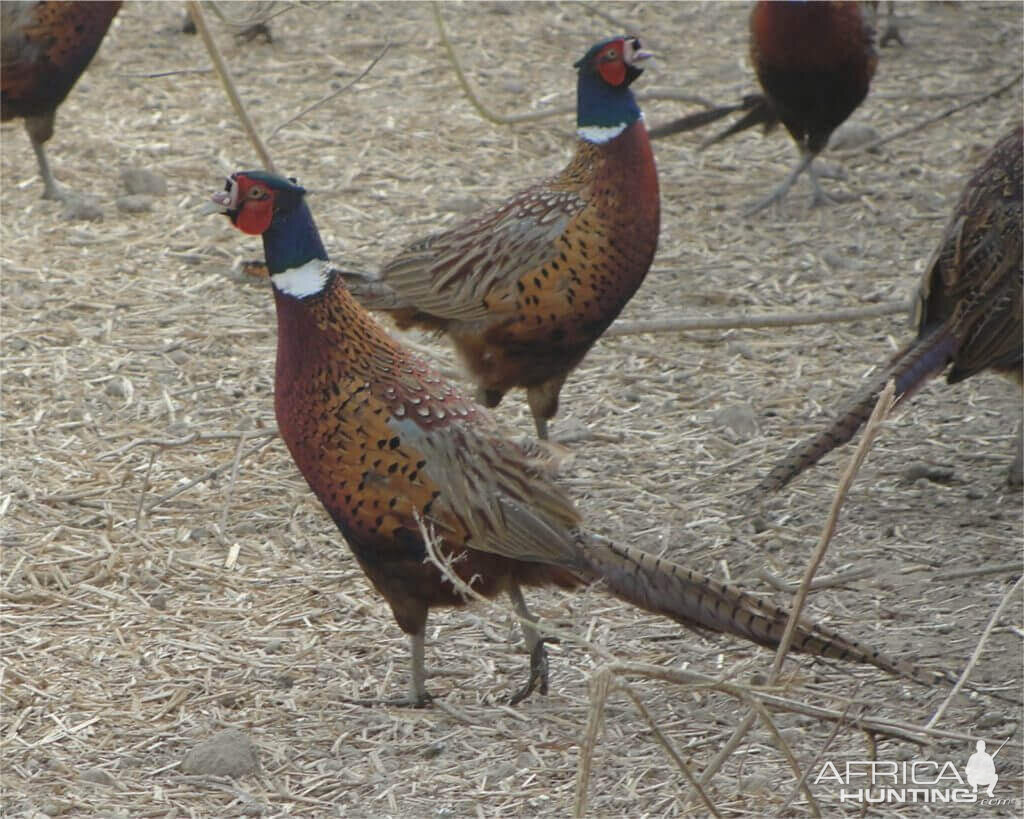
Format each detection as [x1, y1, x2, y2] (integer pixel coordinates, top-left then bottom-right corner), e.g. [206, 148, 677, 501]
[348, 37, 659, 438]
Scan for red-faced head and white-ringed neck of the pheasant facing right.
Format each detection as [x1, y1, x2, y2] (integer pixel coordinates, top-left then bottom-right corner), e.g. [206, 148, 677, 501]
[575, 36, 651, 142]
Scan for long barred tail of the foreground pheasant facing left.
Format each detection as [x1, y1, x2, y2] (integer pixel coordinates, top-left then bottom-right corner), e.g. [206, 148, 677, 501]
[584, 534, 948, 686]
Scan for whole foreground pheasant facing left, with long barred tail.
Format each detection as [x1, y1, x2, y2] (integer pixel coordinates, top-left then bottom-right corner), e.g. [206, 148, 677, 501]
[213, 165, 950, 705]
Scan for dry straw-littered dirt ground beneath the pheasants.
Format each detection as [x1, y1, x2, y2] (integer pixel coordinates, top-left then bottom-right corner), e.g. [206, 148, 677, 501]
[0, 2, 1024, 817]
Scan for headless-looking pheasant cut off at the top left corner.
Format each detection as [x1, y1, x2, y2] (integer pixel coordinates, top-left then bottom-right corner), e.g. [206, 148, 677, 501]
[0, 0, 121, 199]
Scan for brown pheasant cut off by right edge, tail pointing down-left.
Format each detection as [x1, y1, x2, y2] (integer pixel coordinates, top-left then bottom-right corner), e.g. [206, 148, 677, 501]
[755, 127, 1024, 493]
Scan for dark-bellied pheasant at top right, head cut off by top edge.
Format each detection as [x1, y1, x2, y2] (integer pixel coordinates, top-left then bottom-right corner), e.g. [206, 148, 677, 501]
[650, 0, 878, 215]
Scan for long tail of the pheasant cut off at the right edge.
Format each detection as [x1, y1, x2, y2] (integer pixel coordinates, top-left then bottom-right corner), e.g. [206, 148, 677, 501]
[753, 328, 956, 498]
